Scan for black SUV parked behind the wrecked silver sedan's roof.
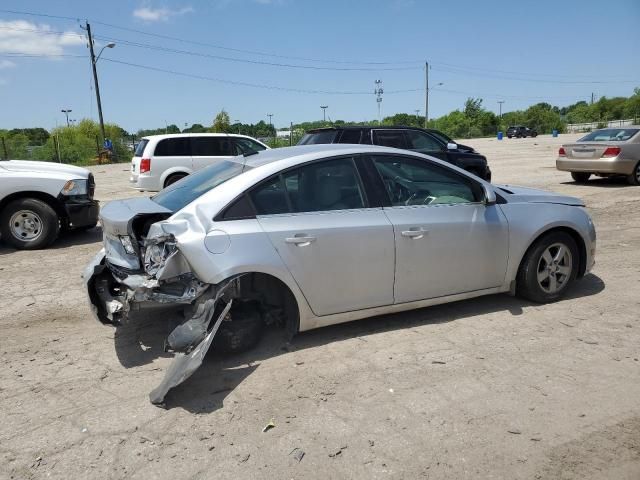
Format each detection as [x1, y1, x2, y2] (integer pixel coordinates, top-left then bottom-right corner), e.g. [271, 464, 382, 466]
[298, 126, 491, 182]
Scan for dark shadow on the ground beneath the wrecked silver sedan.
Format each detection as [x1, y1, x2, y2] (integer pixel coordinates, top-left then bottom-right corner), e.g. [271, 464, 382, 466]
[110, 274, 605, 413]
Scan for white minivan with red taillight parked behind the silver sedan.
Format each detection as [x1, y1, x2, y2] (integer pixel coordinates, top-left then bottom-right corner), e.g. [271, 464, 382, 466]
[129, 133, 269, 192]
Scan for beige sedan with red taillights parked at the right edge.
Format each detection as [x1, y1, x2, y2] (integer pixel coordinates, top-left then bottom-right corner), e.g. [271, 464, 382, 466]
[556, 125, 640, 185]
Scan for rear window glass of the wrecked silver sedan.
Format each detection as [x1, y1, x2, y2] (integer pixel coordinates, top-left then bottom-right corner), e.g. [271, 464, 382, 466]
[151, 160, 251, 212]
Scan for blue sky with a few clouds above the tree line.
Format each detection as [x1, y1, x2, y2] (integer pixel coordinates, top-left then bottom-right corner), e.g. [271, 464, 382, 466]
[0, 0, 640, 132]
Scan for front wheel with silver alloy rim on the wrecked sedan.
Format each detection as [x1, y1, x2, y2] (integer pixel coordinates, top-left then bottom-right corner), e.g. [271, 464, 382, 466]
[516, 231, 580, 303]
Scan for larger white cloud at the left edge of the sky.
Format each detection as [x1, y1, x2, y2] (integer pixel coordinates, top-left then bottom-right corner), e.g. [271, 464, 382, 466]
[0, 20, 86, 55]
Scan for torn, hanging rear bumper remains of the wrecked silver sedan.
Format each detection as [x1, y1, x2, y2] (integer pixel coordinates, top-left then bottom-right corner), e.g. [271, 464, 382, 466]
[83, 251, 237, 405]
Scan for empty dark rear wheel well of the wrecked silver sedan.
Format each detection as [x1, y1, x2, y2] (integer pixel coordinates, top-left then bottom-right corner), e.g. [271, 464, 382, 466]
[230, 272, 300, 337]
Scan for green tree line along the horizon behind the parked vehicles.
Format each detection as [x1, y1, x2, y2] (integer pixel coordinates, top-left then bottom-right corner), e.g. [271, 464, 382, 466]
[0, 88, 640, 165]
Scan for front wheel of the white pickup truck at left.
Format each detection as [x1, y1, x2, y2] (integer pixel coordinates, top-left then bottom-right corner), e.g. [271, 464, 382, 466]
[0, 198, 60, 250]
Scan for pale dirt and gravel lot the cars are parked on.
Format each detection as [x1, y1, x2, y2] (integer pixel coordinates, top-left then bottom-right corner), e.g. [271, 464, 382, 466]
[0, 135, 640, 479]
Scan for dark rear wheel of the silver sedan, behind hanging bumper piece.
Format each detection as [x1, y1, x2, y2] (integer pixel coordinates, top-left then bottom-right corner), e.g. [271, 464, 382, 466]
[212, 302, 264, 353]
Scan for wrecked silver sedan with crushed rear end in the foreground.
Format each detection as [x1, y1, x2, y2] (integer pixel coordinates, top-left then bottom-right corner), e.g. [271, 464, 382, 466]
[84, 145, 596, 403]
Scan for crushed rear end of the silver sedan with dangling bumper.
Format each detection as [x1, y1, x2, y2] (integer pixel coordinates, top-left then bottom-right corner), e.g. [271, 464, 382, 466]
[83, 199, 239, 404]
